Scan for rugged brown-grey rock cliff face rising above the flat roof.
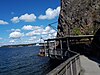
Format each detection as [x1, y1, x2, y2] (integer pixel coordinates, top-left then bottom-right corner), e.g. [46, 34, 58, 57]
[57, 0, 100, 37]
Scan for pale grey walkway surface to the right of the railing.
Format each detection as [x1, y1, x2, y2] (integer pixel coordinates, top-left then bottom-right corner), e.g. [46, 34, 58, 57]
[80, 56, 100, 75]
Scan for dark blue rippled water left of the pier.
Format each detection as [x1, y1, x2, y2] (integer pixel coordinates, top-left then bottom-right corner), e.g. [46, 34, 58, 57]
[0, 46, 58, 75]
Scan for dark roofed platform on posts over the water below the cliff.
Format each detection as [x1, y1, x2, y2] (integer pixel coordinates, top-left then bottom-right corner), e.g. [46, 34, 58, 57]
[45, 35, 93, 59]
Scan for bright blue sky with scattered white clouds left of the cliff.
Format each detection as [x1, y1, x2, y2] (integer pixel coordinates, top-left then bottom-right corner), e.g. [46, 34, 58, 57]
[0, 0, 60, 46]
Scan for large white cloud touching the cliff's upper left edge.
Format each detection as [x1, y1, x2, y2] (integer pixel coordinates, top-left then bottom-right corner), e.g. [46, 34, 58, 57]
[38, 6, 60, 20]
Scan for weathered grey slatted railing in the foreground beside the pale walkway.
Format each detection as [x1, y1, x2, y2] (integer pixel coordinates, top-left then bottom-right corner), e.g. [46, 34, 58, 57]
[47, 54, 81, 75]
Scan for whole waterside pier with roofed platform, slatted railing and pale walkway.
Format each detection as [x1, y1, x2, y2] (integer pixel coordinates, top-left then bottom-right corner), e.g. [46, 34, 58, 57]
[39, 35, 100, 75]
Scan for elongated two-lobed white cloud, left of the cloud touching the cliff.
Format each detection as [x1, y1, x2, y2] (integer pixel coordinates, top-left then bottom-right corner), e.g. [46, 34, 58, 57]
[11, 13, 36, 23]
